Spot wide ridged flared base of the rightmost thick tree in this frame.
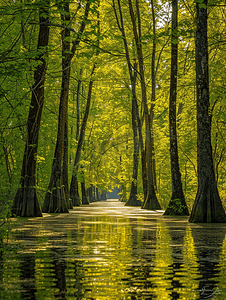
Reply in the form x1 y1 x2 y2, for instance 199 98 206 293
189 178 226 223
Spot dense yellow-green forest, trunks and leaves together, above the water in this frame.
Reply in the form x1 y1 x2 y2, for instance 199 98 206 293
0 0 226 222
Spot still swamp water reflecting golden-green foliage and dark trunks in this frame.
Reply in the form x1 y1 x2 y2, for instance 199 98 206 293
0 200 226 300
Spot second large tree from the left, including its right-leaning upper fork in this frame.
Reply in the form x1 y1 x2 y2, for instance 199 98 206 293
43 0 90 213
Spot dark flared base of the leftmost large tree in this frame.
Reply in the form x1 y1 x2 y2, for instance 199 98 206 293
11 187 42 217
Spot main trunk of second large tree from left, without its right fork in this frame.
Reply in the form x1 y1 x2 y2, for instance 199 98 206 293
43 2 71 213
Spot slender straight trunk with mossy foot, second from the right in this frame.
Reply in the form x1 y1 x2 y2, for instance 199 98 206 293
164 0 189 216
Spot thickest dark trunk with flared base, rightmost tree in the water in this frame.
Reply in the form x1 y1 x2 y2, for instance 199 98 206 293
189 0 226 223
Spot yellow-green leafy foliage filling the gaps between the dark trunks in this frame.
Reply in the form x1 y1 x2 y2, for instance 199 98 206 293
0 0 226 213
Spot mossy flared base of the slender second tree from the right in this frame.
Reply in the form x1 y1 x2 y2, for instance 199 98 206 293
163 199 189 216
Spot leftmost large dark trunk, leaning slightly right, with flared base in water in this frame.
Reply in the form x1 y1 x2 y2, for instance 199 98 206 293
12 1 49 217
